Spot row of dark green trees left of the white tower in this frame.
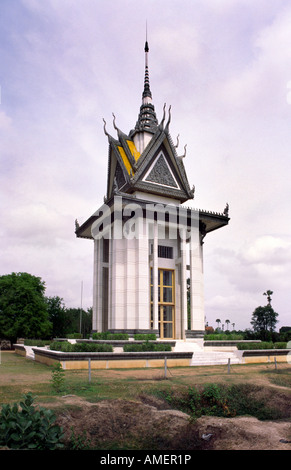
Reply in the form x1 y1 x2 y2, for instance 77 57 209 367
0 272 92 343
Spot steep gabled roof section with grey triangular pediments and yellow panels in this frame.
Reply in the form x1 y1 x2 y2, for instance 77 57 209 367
107 116 194 203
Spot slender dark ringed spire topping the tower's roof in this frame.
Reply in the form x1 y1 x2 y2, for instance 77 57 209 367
135 32 158 133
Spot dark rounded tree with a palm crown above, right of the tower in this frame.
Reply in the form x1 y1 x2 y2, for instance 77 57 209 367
251 291 278 340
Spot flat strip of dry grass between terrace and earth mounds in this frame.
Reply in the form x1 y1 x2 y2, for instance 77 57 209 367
0 351 291 404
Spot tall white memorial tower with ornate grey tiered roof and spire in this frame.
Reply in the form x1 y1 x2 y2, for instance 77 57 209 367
76 41 229 339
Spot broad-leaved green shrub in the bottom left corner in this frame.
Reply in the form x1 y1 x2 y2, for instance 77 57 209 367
0 393 63 450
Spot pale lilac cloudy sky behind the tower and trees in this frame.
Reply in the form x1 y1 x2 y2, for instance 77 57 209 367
0 0 291 330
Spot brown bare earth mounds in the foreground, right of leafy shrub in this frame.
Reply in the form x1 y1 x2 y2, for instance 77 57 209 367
54 396 291 450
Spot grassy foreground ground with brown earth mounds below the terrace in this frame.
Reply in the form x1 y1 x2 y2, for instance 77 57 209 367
0 351 291 450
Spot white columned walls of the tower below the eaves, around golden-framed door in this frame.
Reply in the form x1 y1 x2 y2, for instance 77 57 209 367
93 208 204 339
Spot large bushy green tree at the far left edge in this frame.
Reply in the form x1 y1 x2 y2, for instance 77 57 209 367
0 273 52 342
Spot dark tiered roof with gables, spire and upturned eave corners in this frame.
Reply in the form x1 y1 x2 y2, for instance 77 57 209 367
75 41 229 238
